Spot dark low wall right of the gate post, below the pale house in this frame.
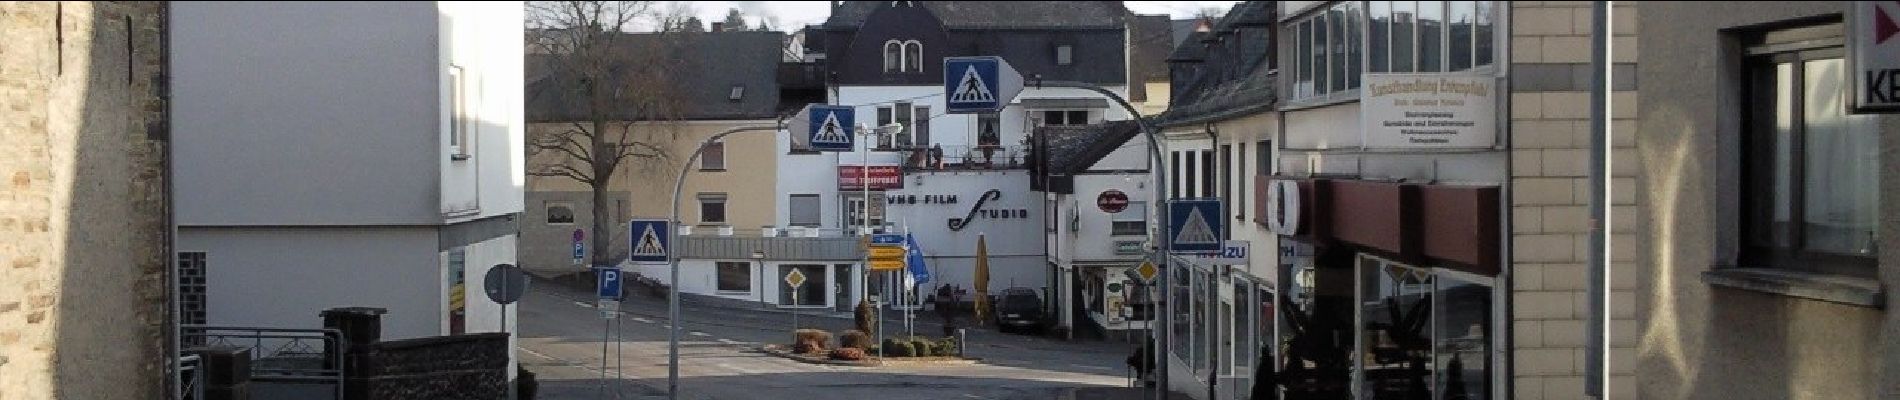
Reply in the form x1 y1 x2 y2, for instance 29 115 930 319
367 334 509 400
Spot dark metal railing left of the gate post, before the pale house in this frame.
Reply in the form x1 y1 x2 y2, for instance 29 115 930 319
181 324 346 398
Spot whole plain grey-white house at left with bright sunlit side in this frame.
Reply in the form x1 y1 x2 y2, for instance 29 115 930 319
169 2 526 346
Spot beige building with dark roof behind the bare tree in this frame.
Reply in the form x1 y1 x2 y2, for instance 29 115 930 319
521 30 804 282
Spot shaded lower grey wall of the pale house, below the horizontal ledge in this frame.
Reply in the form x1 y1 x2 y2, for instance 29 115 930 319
179 227 440 339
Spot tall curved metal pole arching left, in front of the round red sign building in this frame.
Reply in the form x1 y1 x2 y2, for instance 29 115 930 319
1036 82 1174 398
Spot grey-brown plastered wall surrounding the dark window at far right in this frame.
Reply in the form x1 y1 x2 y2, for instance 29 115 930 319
1634 2 1900 398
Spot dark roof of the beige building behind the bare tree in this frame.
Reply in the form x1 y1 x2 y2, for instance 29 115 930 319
524 32 785 121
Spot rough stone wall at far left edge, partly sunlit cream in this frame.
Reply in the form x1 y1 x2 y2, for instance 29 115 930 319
0 2 171 400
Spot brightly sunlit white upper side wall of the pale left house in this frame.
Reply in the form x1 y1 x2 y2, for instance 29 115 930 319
437 2 526 222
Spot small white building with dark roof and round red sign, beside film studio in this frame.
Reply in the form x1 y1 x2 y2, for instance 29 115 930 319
1030 121 1155 339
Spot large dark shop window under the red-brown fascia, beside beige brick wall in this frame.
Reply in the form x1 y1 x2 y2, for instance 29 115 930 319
1355 256 1495 398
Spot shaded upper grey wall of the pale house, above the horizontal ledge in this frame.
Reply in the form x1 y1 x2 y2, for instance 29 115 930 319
171 2 437 226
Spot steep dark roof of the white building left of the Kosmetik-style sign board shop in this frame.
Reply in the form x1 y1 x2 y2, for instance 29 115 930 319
1155 2 1277 127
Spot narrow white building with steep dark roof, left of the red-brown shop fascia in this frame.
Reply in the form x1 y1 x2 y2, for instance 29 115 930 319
1155 2 1281 398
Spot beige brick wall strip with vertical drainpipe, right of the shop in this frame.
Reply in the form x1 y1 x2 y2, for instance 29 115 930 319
1511 2 1640 400
